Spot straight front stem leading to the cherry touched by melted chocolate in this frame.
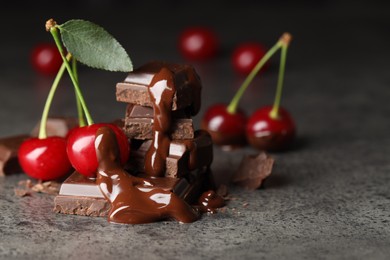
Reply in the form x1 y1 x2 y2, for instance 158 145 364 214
50 25 93 125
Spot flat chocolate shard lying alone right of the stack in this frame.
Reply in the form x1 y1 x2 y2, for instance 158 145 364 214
232 152 274 190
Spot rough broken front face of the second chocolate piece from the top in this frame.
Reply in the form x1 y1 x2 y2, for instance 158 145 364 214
123 118 194 140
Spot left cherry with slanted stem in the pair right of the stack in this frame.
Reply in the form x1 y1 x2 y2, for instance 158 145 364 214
201 34 281 148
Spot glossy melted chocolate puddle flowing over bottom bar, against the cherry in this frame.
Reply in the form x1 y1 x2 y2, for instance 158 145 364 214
95 127 199 224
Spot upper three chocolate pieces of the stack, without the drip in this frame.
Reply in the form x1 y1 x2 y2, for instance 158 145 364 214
116 62 213 178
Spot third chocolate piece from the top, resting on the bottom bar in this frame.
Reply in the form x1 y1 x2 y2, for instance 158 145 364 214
128 130 213 178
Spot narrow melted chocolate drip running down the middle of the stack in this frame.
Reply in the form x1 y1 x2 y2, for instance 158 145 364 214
145 67 176 177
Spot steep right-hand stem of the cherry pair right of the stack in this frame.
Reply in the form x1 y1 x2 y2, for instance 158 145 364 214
269 35 291 119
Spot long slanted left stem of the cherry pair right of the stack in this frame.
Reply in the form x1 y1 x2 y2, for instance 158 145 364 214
227 40 282 114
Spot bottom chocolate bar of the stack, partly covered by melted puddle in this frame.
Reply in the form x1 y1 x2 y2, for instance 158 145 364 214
54 171 207 217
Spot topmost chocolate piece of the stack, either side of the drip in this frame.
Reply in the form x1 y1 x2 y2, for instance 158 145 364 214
116 62 201 115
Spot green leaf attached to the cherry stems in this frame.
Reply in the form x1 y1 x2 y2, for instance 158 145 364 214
58 20 133 72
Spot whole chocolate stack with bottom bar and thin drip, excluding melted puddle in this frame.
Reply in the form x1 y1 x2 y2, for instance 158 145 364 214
55 62 213 216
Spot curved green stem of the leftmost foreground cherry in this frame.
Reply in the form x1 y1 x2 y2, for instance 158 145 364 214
38 54 72 139
